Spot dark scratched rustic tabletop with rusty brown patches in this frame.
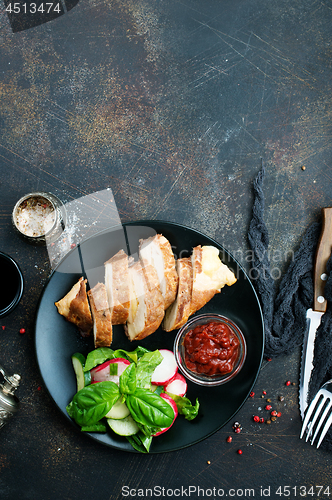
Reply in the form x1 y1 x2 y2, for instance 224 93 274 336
0 0 332 500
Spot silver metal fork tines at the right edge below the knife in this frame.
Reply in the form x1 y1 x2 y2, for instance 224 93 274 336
300 379 332 448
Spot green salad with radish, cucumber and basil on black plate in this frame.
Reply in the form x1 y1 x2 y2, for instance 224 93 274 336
66 347 199 453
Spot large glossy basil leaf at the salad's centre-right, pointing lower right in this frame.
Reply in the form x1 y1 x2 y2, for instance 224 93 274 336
126 389 174 427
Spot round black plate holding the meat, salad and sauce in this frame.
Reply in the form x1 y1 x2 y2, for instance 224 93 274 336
35 221 264 453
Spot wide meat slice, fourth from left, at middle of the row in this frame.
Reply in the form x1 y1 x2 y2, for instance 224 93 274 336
125 261 164 340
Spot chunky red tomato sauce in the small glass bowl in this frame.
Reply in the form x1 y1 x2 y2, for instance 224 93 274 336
183 322 240 375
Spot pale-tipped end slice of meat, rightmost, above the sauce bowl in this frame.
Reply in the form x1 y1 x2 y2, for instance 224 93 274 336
190 245 236 314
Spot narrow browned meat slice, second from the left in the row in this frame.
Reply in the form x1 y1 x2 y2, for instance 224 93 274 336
88 283 112 348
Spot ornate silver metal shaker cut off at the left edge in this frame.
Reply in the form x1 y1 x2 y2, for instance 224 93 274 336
0 366 21 429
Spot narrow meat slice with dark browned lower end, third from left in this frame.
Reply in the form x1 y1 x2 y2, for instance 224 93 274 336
105 250 130 325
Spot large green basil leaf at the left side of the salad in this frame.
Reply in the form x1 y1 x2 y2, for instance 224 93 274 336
67 381 120 427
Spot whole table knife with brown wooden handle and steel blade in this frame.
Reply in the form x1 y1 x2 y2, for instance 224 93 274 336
299 207 332 419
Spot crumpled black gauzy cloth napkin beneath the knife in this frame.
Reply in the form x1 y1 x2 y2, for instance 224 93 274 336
248 166 332 451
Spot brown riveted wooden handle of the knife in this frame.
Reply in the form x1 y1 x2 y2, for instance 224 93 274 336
313 207 332 313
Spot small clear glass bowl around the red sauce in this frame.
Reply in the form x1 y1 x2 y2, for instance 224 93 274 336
173 313 247 387
